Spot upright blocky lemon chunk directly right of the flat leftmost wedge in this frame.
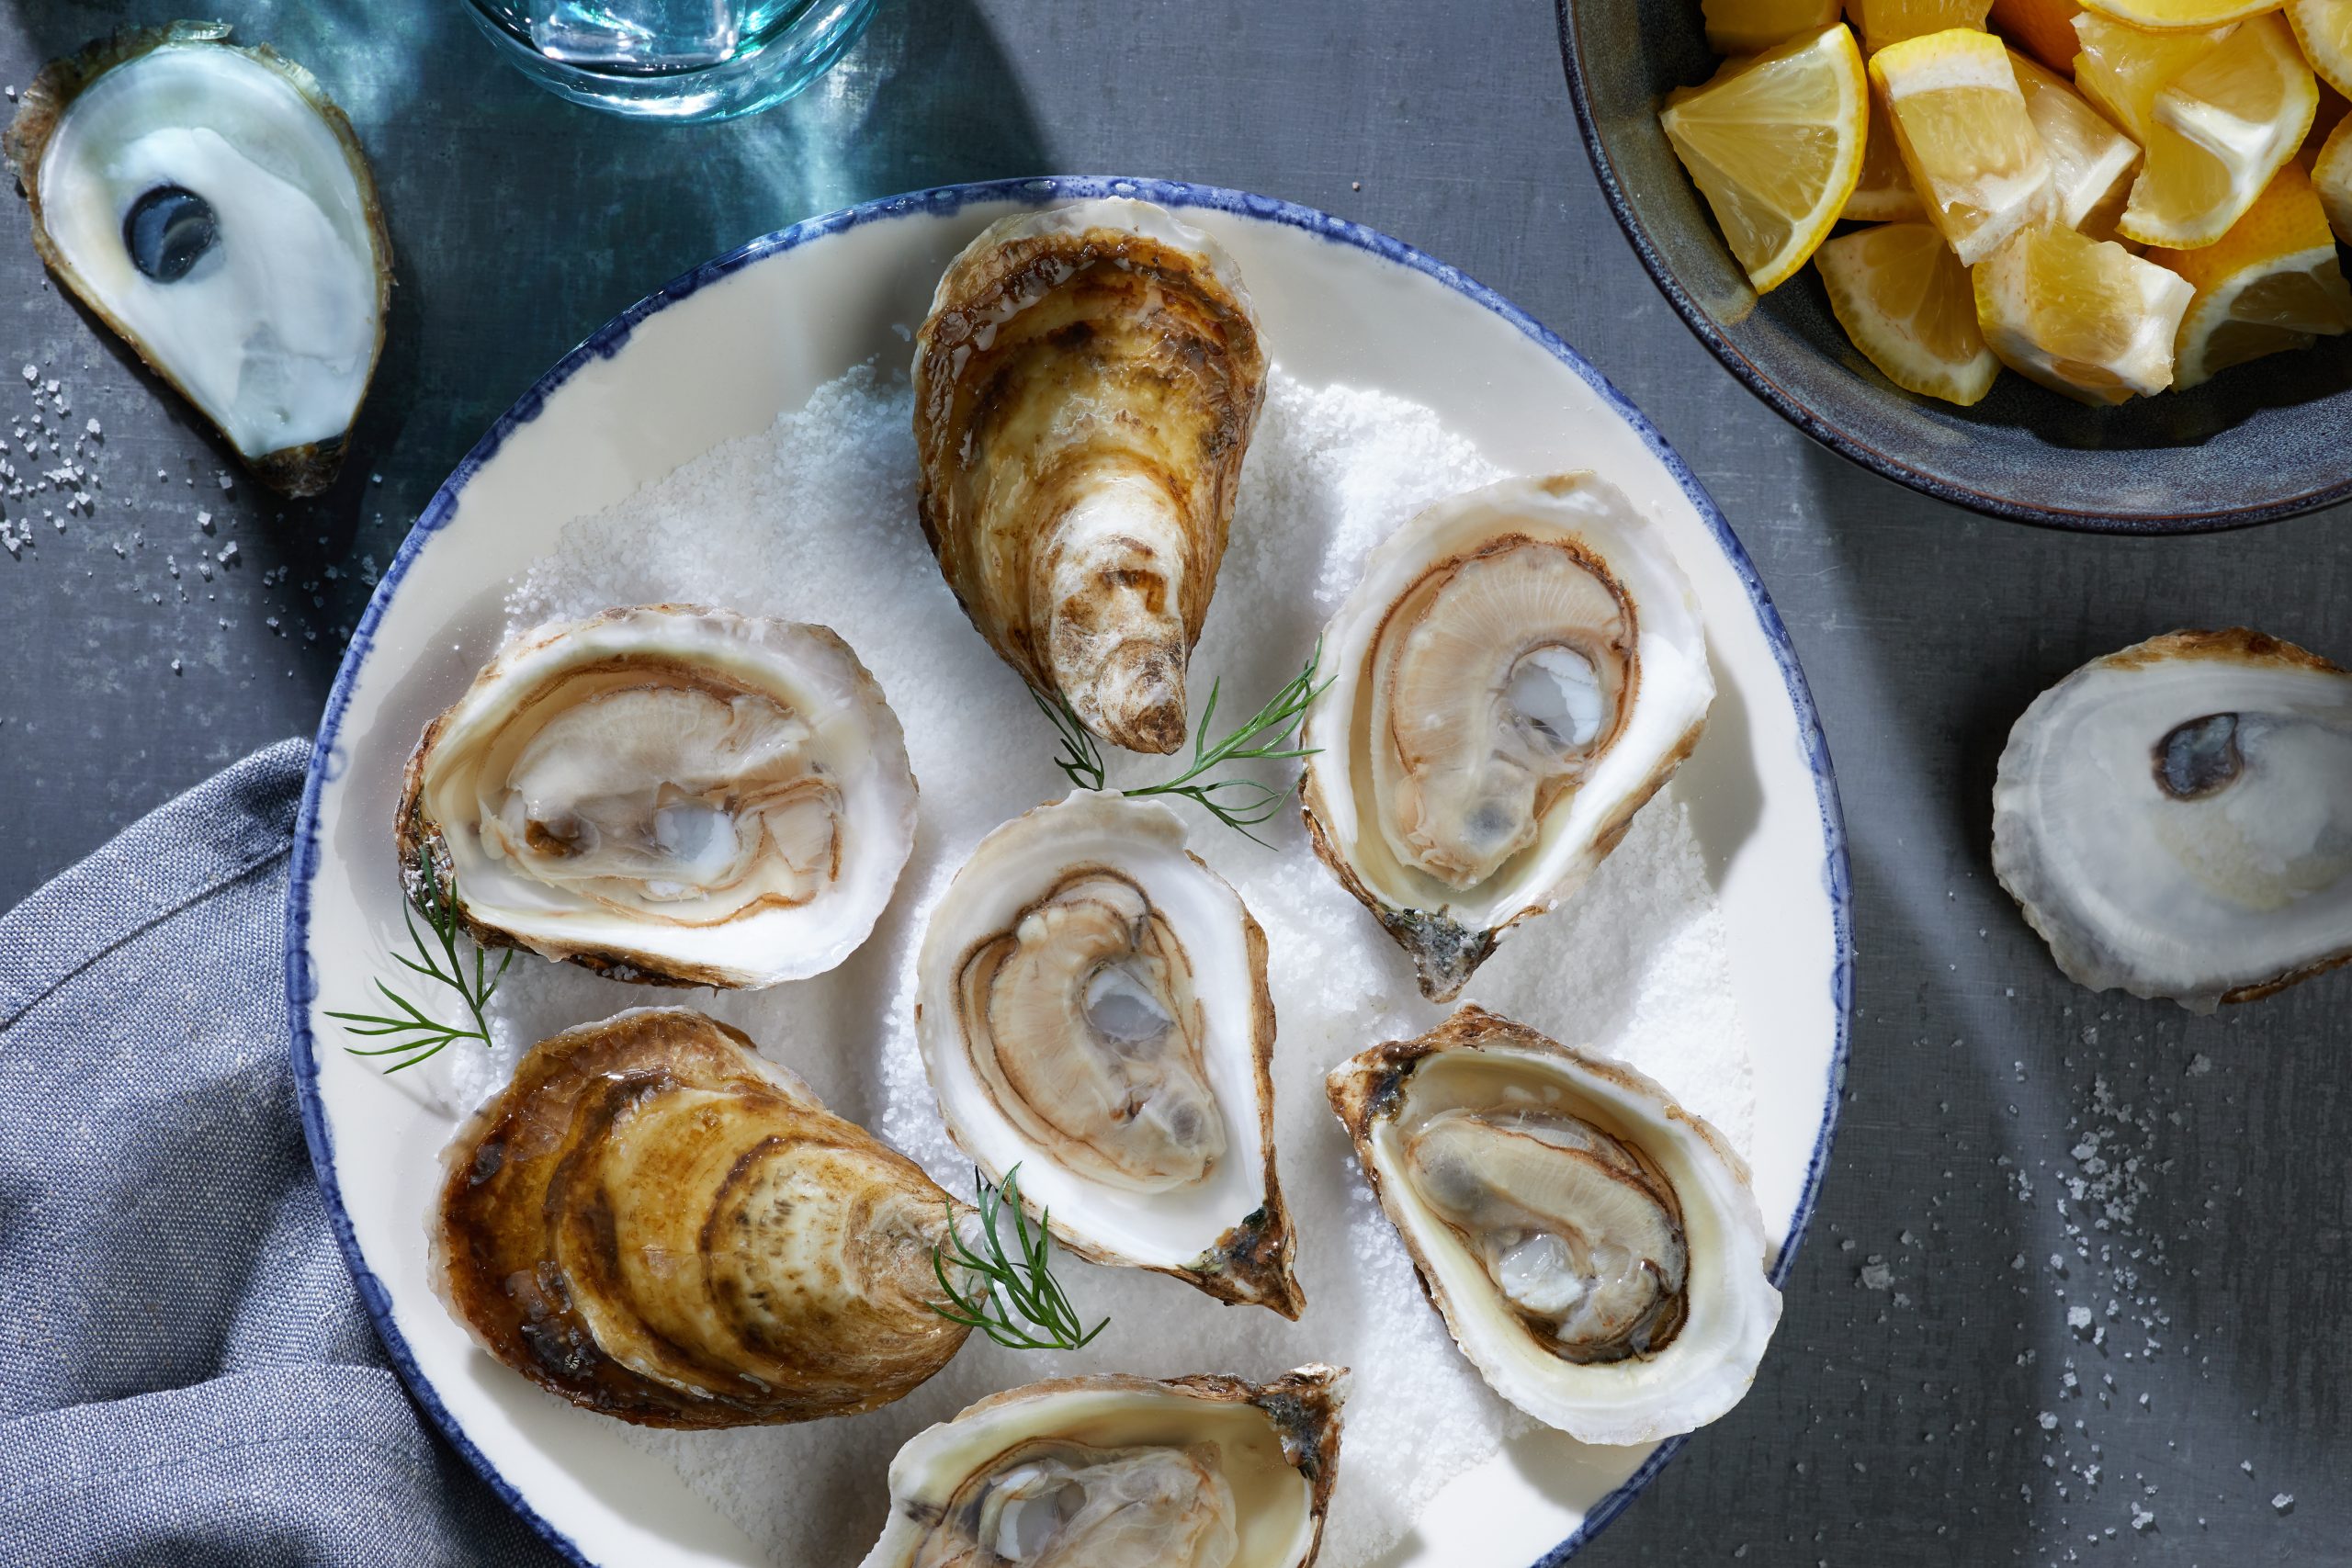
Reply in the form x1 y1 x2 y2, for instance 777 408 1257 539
1870 28 2058 265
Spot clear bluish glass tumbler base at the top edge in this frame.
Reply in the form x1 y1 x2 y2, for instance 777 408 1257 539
466 0 877 120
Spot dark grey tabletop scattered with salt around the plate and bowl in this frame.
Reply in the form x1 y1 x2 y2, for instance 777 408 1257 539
0 0 2352 1565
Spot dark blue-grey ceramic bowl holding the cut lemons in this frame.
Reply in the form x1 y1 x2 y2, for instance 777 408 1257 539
1555 0 2352 534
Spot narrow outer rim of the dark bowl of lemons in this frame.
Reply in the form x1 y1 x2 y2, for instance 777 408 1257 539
1553 0 2352 536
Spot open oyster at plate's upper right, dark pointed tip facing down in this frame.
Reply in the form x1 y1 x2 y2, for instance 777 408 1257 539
1301 472 1714 1001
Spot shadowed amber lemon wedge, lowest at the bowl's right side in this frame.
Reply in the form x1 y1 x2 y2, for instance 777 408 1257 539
2154 163 2352 388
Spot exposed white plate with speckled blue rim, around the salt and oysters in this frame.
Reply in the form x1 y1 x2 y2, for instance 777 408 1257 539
287 179 1851 1568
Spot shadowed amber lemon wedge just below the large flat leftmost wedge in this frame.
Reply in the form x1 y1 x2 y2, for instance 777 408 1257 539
1814 223 2002 407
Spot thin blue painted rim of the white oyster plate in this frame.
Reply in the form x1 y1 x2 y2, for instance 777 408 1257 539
285 174 1853 1568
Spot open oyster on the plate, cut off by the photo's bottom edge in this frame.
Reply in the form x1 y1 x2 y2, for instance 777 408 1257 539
864 1366 1348 1568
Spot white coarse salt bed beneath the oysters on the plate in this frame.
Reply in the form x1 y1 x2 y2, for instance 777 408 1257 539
430 367 1752 1568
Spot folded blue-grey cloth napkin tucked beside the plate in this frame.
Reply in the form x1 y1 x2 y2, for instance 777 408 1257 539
0 740 560 1568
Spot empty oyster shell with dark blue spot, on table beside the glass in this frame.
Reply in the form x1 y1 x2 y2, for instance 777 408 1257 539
0 21 393 496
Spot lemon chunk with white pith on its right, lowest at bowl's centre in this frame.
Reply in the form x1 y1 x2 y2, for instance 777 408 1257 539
1973 223 2197 404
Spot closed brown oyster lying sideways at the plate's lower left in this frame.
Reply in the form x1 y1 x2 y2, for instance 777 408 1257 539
430 1009 967 1427
